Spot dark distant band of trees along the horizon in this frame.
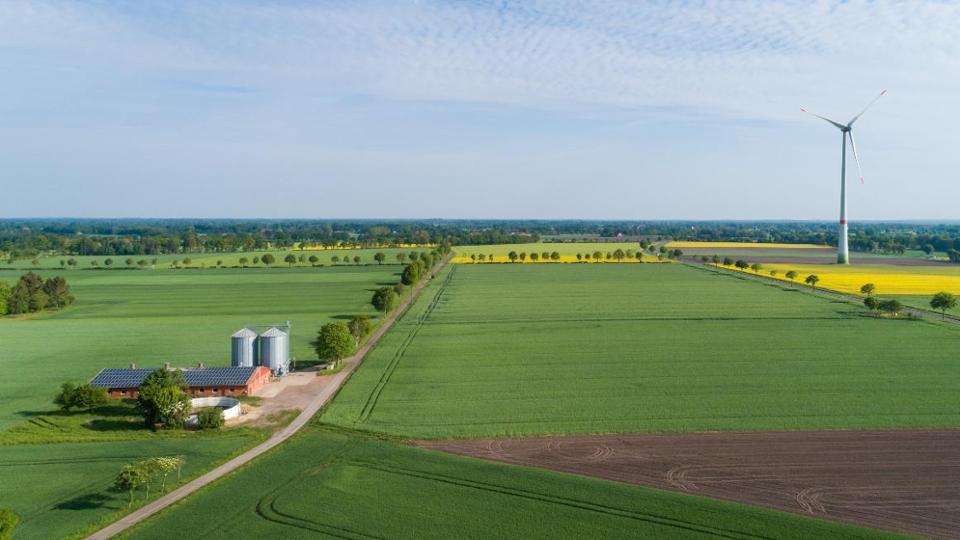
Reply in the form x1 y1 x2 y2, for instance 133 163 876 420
0 219 960 262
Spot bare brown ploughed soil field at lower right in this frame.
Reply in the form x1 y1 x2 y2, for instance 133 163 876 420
417 430 960 538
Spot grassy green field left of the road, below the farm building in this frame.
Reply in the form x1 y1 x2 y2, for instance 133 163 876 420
0 435 255 540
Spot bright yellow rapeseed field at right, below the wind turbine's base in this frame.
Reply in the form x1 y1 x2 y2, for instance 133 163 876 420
746 263 960 295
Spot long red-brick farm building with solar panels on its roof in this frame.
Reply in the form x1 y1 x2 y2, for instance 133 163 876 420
90 366 270 398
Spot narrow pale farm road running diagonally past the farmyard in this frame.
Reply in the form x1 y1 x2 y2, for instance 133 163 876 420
86 257 449 540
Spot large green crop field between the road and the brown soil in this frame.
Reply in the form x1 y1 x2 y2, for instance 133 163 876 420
323 265 960 438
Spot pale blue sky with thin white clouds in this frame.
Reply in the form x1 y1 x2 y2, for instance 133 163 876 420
0 0 960 221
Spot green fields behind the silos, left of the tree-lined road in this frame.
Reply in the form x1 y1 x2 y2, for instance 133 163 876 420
0 265 399 430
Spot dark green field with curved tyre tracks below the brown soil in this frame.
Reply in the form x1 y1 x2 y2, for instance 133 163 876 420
124 427 886 539
